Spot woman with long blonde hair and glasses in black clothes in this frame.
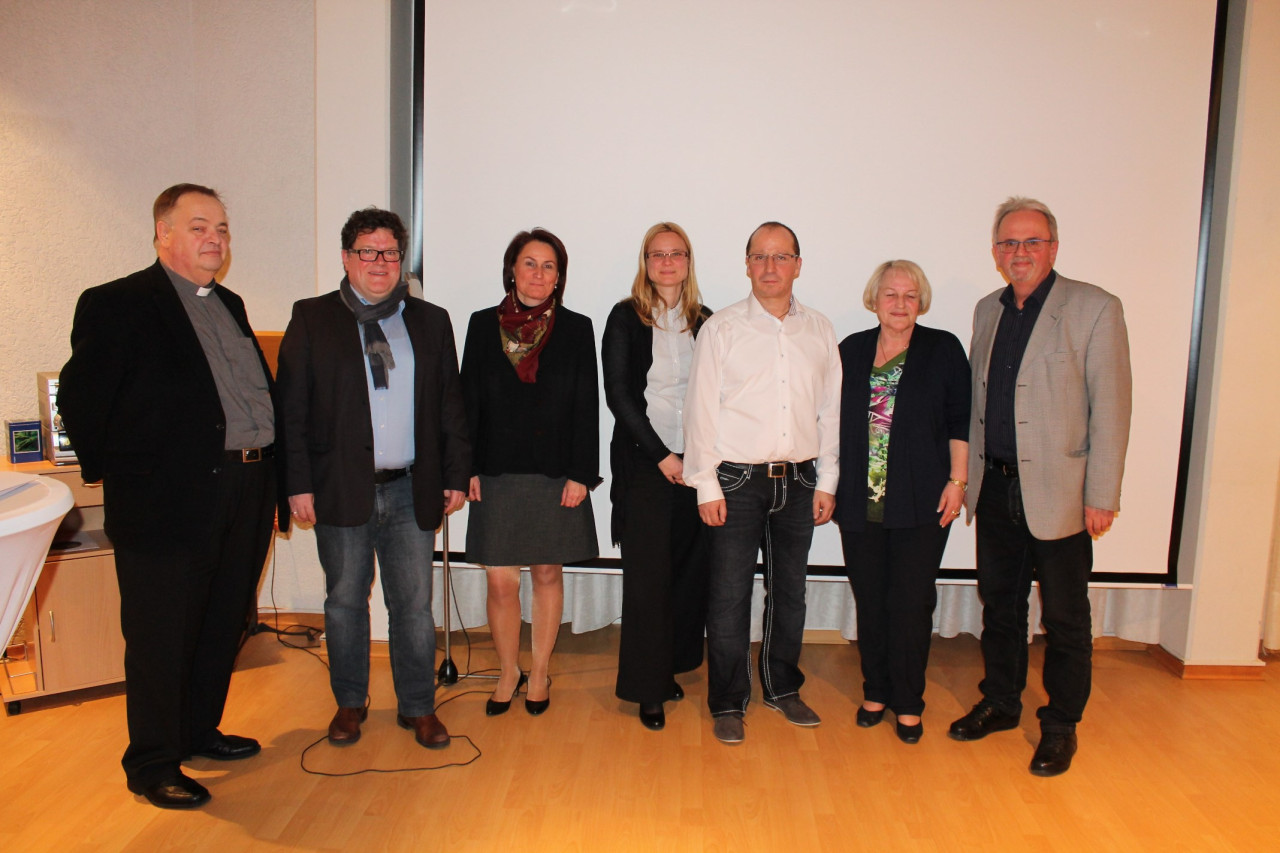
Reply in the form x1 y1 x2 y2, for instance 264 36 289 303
602 222 710 729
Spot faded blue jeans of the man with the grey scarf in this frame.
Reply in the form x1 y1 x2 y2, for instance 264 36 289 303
315 474 435 717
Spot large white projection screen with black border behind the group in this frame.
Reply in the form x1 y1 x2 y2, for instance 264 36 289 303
421 0 1215 583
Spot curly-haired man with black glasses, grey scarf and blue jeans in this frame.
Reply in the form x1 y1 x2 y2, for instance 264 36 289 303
279 207 471 749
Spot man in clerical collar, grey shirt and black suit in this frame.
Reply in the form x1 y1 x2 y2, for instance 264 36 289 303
58 183 278 808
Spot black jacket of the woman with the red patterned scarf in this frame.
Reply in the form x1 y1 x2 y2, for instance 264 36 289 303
462 305 600 488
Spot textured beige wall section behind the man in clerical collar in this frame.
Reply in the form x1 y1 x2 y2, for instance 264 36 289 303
0 0 316 418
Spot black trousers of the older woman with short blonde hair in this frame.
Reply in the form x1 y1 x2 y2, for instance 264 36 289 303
840 521 954 715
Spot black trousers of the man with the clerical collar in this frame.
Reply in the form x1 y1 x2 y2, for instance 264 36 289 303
115 459 275 785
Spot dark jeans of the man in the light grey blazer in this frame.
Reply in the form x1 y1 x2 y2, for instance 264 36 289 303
977 470 1093 731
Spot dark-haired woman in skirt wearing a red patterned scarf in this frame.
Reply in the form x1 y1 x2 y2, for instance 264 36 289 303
462 228 600 716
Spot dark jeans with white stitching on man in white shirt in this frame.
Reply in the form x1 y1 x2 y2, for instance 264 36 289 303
707 460 817 716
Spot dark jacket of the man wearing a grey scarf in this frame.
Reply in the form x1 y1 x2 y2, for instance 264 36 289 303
278 291 471 530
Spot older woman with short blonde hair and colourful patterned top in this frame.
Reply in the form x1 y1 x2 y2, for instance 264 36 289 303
836 260 970 743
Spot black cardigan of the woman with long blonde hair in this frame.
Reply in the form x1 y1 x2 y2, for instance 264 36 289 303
600 297 712 544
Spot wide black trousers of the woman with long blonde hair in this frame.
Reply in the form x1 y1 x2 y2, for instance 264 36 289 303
616 440 707 702
